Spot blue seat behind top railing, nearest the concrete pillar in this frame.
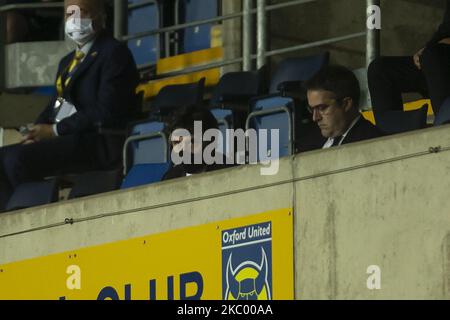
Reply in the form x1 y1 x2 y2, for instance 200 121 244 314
176 0 218 53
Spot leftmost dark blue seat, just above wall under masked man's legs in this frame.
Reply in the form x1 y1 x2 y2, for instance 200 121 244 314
6 179 58 211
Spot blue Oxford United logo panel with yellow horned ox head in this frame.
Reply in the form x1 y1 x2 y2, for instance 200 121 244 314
222 222 272 300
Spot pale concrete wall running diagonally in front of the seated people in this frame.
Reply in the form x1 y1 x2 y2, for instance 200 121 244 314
0 127 450 299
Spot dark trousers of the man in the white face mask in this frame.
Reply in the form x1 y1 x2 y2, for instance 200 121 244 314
0 135 121 212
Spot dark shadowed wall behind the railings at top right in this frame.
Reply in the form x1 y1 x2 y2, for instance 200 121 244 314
270 0 445 69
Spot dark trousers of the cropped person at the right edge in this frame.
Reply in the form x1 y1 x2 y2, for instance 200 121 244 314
368 44 450 117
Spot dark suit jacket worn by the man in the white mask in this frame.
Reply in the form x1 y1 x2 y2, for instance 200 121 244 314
36 33 139 136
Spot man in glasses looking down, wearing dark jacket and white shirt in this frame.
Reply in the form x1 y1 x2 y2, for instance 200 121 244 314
297 66 381 152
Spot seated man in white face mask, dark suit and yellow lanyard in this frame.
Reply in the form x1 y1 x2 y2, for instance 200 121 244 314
0 0 139 211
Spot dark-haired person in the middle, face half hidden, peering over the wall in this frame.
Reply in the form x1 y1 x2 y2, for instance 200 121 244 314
163 106 230 180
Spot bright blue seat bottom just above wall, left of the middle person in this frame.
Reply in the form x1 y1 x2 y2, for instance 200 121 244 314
121 163 170 189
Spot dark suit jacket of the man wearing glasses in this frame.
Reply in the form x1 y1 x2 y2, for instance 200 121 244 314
296 116 383 152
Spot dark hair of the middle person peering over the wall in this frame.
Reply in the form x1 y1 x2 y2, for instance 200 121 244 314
167 106 219 134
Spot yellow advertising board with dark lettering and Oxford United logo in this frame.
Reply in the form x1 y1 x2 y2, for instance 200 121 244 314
0 209 294 300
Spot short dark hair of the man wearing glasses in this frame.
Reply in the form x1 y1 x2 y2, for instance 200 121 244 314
303 65 361 109
